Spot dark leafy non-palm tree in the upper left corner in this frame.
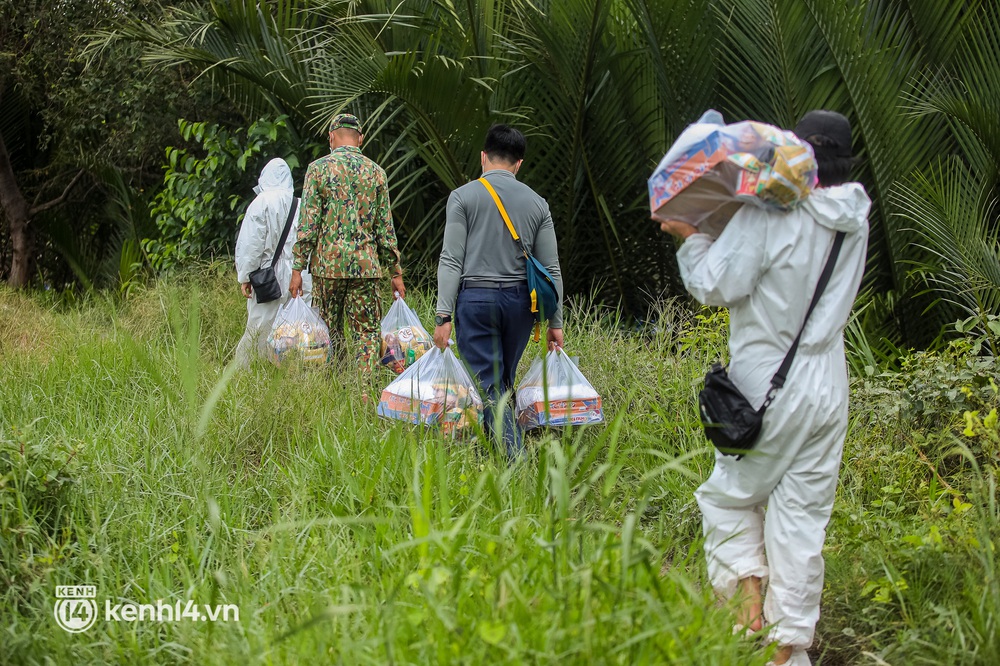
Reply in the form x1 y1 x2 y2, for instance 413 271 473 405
0 0 237 289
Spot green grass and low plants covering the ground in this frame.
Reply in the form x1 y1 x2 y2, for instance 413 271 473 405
0 264 1000 666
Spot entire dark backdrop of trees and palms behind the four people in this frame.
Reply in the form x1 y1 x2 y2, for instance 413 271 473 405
0 0 1000 348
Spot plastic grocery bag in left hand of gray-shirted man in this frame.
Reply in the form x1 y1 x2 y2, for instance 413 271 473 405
378 347 483 433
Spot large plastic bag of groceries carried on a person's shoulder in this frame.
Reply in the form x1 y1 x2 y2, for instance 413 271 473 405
648 111 818 235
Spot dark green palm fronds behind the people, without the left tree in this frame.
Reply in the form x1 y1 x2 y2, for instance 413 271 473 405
95 0 1000 342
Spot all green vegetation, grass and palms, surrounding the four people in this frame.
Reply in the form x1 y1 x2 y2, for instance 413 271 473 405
0 0 1000 666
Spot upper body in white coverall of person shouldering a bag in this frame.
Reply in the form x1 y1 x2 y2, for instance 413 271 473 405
681 183 871 406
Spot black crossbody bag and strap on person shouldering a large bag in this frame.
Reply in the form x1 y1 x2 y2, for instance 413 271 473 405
698 231 846 460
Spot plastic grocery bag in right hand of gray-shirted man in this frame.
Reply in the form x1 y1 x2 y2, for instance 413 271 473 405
517 349 604 430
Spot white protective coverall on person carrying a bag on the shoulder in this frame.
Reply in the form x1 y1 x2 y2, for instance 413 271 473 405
677 183 871 666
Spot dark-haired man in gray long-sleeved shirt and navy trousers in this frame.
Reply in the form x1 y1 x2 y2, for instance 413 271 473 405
434 125 563 457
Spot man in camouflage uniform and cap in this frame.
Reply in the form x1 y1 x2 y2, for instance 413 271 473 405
289 113 406 371
